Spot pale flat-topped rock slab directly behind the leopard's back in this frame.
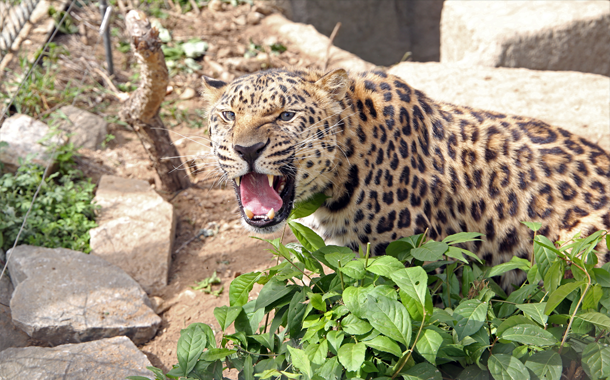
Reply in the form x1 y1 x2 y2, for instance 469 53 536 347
388 62 610 151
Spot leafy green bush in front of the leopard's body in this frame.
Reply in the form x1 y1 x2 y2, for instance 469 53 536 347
137 196 610 380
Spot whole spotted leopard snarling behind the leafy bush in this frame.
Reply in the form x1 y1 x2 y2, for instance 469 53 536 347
203 68 610 289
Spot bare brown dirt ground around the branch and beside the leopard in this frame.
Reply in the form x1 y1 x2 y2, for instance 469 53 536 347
0 0 319 371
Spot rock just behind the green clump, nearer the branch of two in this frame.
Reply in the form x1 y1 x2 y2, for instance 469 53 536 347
53 106 108 150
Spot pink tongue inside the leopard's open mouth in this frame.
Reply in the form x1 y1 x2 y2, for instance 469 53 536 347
239 173 283 216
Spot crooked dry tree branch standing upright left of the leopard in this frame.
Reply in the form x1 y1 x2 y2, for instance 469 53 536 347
120 10 190 192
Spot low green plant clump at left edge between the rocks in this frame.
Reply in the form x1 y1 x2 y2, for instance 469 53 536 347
0 144 97 253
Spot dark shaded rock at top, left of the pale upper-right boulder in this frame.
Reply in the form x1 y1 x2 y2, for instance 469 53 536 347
283 0 443 66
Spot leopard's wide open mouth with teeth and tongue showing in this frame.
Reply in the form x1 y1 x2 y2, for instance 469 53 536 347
233 172 295 228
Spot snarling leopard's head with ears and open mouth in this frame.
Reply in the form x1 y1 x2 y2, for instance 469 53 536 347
204 69 349 233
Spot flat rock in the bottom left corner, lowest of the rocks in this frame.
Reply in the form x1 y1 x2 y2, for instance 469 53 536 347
0 337 154 380
